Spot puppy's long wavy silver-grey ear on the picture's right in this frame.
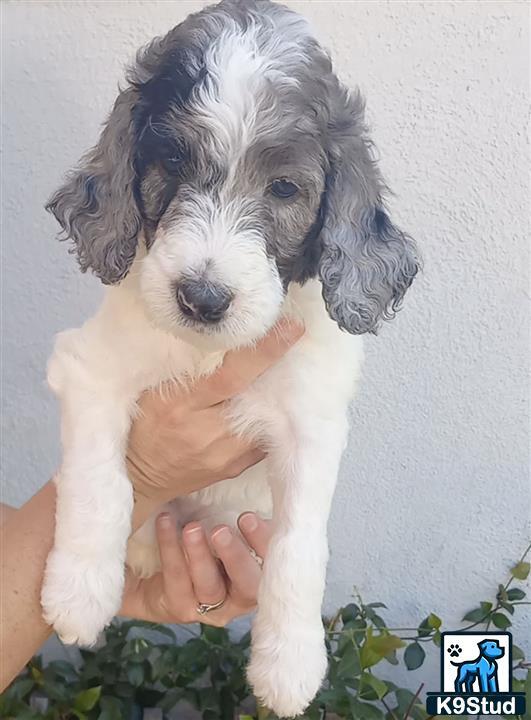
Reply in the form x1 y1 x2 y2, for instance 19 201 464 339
319 77 419 334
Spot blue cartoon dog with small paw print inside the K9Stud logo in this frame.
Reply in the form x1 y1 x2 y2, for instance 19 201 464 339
448 639 505 693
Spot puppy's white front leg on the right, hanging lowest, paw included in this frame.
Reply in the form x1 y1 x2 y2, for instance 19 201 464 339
249 417 347 717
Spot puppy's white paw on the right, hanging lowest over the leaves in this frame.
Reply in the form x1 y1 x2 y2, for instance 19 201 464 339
247 616 327 717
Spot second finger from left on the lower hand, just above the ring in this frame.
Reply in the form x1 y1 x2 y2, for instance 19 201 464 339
183 522 227 605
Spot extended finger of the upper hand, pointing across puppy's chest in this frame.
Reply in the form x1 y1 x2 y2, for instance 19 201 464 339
189 319 304 408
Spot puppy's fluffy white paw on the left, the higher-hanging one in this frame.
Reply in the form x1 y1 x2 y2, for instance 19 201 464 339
41 548 124 646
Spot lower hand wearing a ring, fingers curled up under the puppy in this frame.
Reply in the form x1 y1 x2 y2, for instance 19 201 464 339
120 513 271 627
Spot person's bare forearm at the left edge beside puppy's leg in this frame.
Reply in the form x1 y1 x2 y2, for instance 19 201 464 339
0 482 55 690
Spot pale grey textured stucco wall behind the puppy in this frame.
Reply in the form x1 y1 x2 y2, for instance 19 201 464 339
2 0 531 688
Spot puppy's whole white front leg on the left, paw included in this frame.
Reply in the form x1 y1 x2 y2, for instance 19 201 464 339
41 346 133 645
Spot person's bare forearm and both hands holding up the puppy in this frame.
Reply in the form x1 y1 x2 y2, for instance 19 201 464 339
0 323 303 689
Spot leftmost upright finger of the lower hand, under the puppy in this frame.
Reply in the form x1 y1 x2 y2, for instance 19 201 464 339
157 513 194 601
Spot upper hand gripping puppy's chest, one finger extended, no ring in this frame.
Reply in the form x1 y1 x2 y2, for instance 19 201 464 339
127 320 304 518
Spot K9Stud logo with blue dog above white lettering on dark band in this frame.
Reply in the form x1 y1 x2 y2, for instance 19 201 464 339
426 632 525 715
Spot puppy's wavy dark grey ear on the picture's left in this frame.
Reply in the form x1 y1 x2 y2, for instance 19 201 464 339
46 88 141 285
